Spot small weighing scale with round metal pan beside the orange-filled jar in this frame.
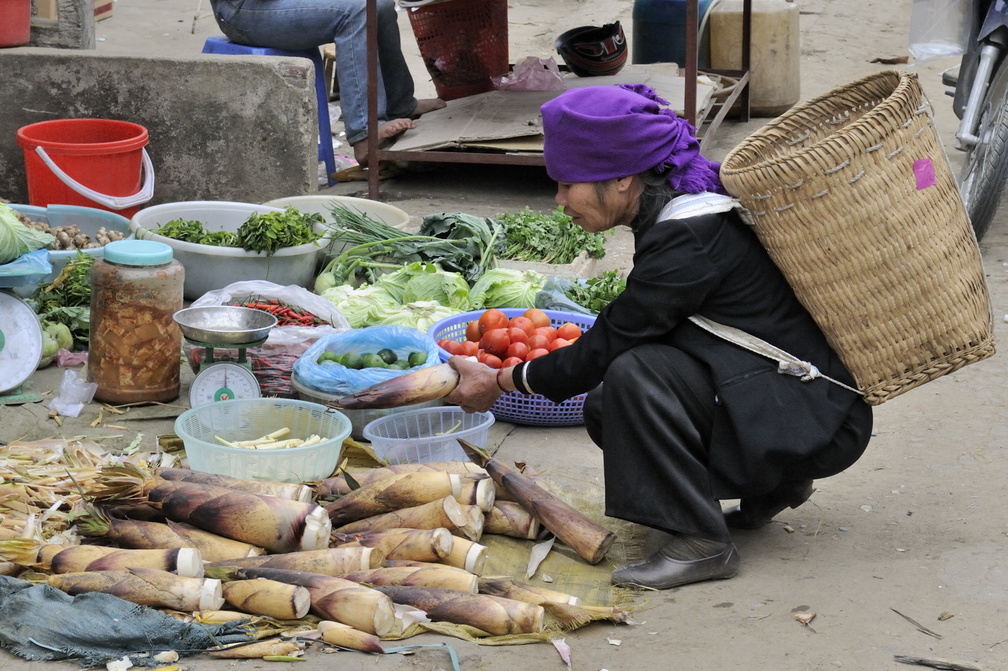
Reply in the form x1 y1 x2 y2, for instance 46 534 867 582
173 305 277 408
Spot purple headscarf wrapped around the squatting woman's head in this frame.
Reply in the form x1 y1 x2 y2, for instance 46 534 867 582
540 84 725 193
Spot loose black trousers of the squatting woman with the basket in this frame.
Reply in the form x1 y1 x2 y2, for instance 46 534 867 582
585 345 871 541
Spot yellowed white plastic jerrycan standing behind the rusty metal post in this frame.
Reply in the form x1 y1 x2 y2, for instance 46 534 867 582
711 0 801 117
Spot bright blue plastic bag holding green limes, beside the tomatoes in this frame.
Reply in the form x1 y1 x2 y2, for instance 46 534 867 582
294 325 440 396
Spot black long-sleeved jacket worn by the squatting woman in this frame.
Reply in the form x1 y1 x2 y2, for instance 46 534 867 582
526 206 871 498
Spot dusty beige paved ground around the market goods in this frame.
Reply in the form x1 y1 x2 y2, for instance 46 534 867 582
0 0 1008 671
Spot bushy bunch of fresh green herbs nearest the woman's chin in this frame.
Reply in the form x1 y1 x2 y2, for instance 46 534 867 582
498 207 606 264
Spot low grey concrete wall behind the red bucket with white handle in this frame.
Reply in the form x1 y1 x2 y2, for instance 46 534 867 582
0 47 319 209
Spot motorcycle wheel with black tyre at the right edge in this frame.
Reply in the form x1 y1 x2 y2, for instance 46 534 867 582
960 58 1008 240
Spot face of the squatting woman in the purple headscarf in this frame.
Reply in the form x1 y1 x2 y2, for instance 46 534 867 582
555 177 637 233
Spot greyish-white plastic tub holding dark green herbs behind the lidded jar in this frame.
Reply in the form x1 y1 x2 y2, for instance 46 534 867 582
129 200 327 300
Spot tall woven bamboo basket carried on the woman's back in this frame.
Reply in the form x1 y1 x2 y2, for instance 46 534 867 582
721 71 994 405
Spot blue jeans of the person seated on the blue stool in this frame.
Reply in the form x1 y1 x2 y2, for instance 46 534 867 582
211 0 416 145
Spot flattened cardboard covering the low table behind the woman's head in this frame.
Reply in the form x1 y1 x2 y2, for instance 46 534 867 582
388 63 715 153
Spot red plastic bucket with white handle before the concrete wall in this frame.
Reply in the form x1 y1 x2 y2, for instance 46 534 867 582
17 119 154 219
